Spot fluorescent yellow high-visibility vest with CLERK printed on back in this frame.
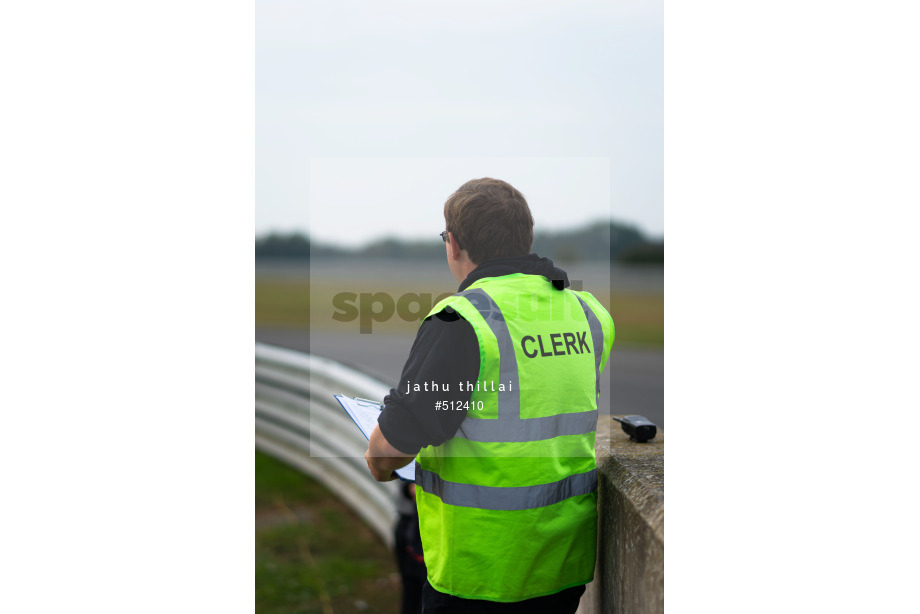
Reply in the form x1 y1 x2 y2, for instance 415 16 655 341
415 273 614 602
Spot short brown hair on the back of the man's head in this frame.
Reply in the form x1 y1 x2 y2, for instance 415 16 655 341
444 177 533 264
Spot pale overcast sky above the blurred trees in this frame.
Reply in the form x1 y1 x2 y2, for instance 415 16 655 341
256 0 664 245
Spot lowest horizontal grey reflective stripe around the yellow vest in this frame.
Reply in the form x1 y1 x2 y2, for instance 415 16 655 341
415 462 597 510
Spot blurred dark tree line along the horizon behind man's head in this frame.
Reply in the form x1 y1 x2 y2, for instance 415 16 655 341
255 221 664 264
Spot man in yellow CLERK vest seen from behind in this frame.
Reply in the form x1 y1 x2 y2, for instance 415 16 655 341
365 178 614 614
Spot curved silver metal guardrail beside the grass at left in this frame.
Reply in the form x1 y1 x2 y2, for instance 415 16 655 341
255 343 397 548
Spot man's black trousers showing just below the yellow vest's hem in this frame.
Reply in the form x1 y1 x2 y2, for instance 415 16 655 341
422 580 585 614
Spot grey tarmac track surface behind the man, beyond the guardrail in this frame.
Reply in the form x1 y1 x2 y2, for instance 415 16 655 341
255 327 664 429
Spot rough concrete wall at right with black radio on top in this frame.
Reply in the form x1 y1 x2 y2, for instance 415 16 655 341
578 418 664 614
